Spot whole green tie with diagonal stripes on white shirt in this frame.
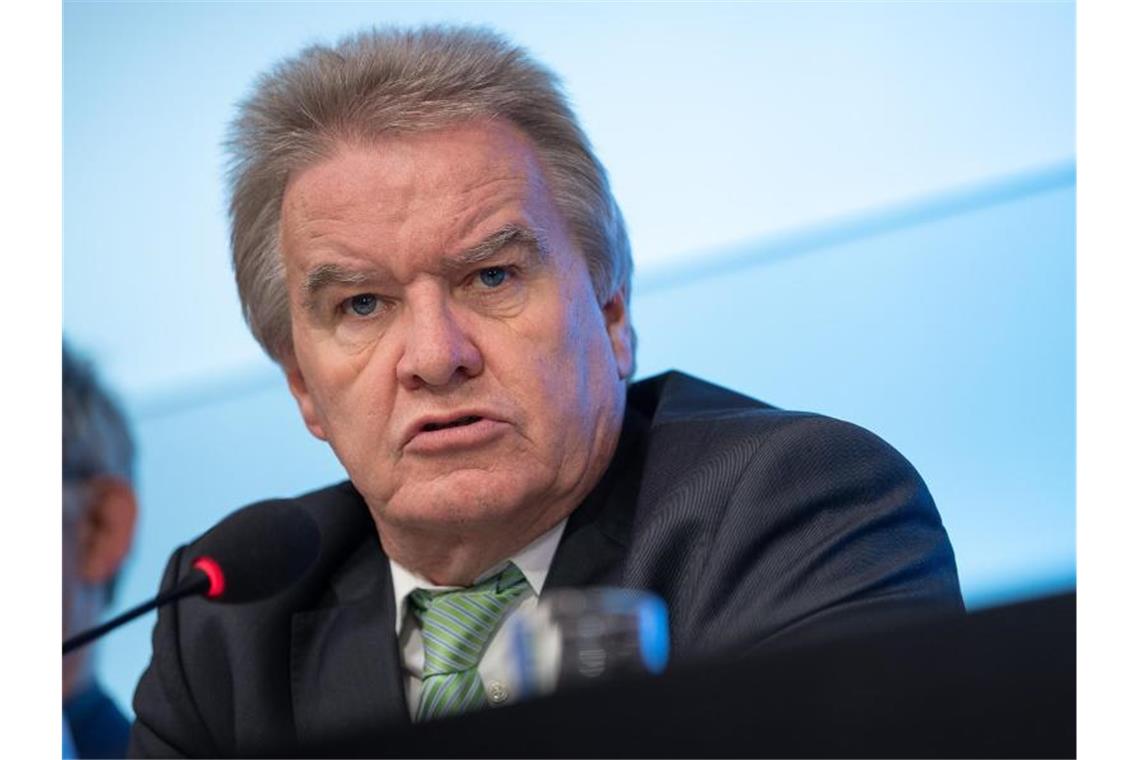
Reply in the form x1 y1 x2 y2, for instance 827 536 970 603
409 564 528 720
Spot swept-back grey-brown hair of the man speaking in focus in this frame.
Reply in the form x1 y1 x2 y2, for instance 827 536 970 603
227 26 633 362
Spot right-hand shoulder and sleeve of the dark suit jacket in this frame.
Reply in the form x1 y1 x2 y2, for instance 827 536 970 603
629 373 961 654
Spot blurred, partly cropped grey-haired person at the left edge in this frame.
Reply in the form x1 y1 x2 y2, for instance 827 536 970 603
63 344 137 758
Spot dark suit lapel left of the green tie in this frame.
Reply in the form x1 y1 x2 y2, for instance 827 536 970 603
291 541 409 755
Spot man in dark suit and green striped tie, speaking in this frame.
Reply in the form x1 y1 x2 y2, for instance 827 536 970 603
133 28 961 755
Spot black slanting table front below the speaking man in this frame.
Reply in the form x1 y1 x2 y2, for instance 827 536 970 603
323 593 1076 758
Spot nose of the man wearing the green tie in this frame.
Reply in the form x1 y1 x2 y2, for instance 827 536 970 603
396 292 483 390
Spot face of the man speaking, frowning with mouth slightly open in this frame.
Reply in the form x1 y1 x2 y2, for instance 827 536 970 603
280 121 633 540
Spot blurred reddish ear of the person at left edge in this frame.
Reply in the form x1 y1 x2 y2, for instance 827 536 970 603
79 475 138 586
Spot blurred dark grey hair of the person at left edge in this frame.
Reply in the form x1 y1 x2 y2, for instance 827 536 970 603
63 343 135 483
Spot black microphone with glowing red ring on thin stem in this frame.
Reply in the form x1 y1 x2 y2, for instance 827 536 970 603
64 501 320 654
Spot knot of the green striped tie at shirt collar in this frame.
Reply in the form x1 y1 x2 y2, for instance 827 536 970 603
409 563 527 678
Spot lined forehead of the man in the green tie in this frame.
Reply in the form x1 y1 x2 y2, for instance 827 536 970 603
282 121 555 259
